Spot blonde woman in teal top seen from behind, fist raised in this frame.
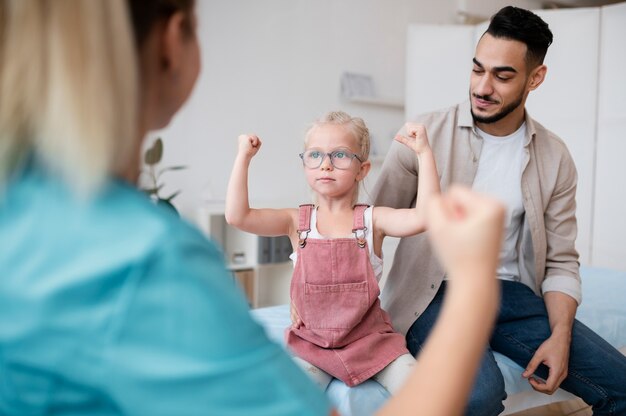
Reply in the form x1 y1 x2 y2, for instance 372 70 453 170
0 0 502 415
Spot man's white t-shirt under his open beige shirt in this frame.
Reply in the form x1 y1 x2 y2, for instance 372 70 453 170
472 123 526 281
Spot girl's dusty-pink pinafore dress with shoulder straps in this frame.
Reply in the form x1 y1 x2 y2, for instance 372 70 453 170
285 205 409 387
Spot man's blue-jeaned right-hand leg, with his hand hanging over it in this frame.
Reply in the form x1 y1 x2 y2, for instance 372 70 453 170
491 281 626 415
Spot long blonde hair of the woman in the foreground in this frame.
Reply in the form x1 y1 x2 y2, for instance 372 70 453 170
0 0 138 195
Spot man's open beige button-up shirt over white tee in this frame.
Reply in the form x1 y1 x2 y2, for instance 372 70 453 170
373 101 582 334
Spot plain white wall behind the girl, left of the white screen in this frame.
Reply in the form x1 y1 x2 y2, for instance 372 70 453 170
148 0 455 219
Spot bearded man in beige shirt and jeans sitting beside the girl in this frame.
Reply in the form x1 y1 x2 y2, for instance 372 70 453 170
374 6 626 415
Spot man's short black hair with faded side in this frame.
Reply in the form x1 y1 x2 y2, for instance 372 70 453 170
485 6 552 69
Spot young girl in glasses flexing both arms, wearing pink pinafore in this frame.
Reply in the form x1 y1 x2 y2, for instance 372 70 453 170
226 112 439 394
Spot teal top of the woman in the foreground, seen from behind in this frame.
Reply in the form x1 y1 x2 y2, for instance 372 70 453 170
0 163 330 416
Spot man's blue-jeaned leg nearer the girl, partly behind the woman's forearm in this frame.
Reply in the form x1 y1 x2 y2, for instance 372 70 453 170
406 282 506 416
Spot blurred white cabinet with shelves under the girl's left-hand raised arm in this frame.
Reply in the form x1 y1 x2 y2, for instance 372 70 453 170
195 205 293 308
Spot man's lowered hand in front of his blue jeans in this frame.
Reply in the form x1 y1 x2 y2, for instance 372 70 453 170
522 333 570 394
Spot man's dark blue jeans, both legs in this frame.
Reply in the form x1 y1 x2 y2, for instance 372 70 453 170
406 281 626 416
